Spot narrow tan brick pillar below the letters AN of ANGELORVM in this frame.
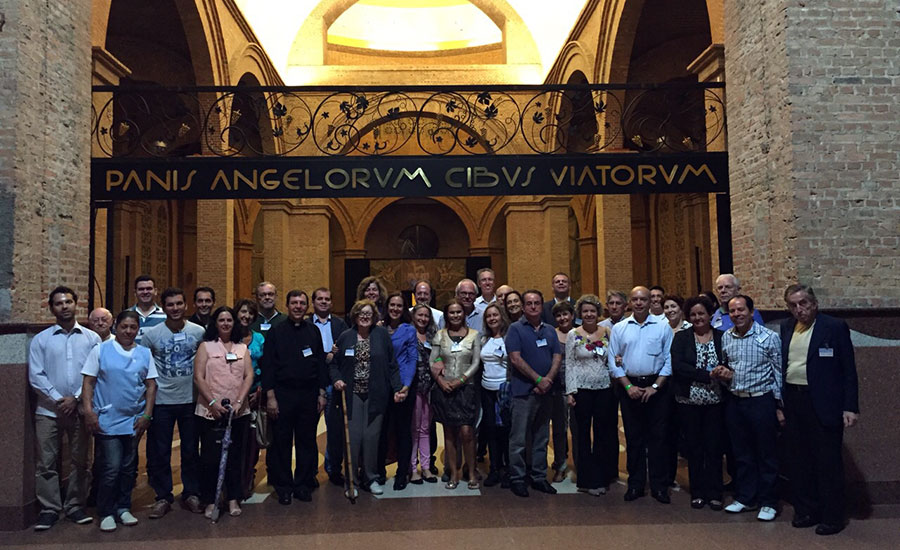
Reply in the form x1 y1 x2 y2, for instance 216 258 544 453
196 199 234 304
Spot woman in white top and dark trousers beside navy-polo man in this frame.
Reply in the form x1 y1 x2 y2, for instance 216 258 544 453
480 303 509 487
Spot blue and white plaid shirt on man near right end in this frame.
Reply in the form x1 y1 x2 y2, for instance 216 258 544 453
722 321 781 401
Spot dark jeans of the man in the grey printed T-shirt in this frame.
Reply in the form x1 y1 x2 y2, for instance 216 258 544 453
147 403 200 502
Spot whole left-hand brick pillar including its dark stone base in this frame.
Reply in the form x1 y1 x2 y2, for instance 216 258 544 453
0 0 91 530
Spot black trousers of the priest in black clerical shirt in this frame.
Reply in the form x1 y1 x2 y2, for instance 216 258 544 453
268 387 319 494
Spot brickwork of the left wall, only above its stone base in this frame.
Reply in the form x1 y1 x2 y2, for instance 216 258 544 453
0 0 91 322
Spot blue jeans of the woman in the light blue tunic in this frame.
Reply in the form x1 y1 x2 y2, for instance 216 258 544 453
94 434 137 517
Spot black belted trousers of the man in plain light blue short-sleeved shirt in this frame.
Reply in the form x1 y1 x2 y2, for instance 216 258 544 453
621 382 670 492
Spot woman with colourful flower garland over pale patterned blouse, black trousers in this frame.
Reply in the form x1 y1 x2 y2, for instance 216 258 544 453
566 294 619 496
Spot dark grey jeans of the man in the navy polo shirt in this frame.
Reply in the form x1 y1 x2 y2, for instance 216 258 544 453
509 393 553 483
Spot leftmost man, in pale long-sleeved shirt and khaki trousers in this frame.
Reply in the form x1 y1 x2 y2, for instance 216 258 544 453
28 286 100 531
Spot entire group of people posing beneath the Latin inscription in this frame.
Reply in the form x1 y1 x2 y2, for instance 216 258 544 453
29 269 859 534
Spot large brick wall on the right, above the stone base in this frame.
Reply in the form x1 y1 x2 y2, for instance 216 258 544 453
725 0 900 308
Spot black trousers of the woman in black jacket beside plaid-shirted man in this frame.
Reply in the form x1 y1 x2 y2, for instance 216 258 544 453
678 403 725 501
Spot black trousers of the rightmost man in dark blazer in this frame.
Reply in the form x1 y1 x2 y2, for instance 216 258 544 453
784 384 844 525
